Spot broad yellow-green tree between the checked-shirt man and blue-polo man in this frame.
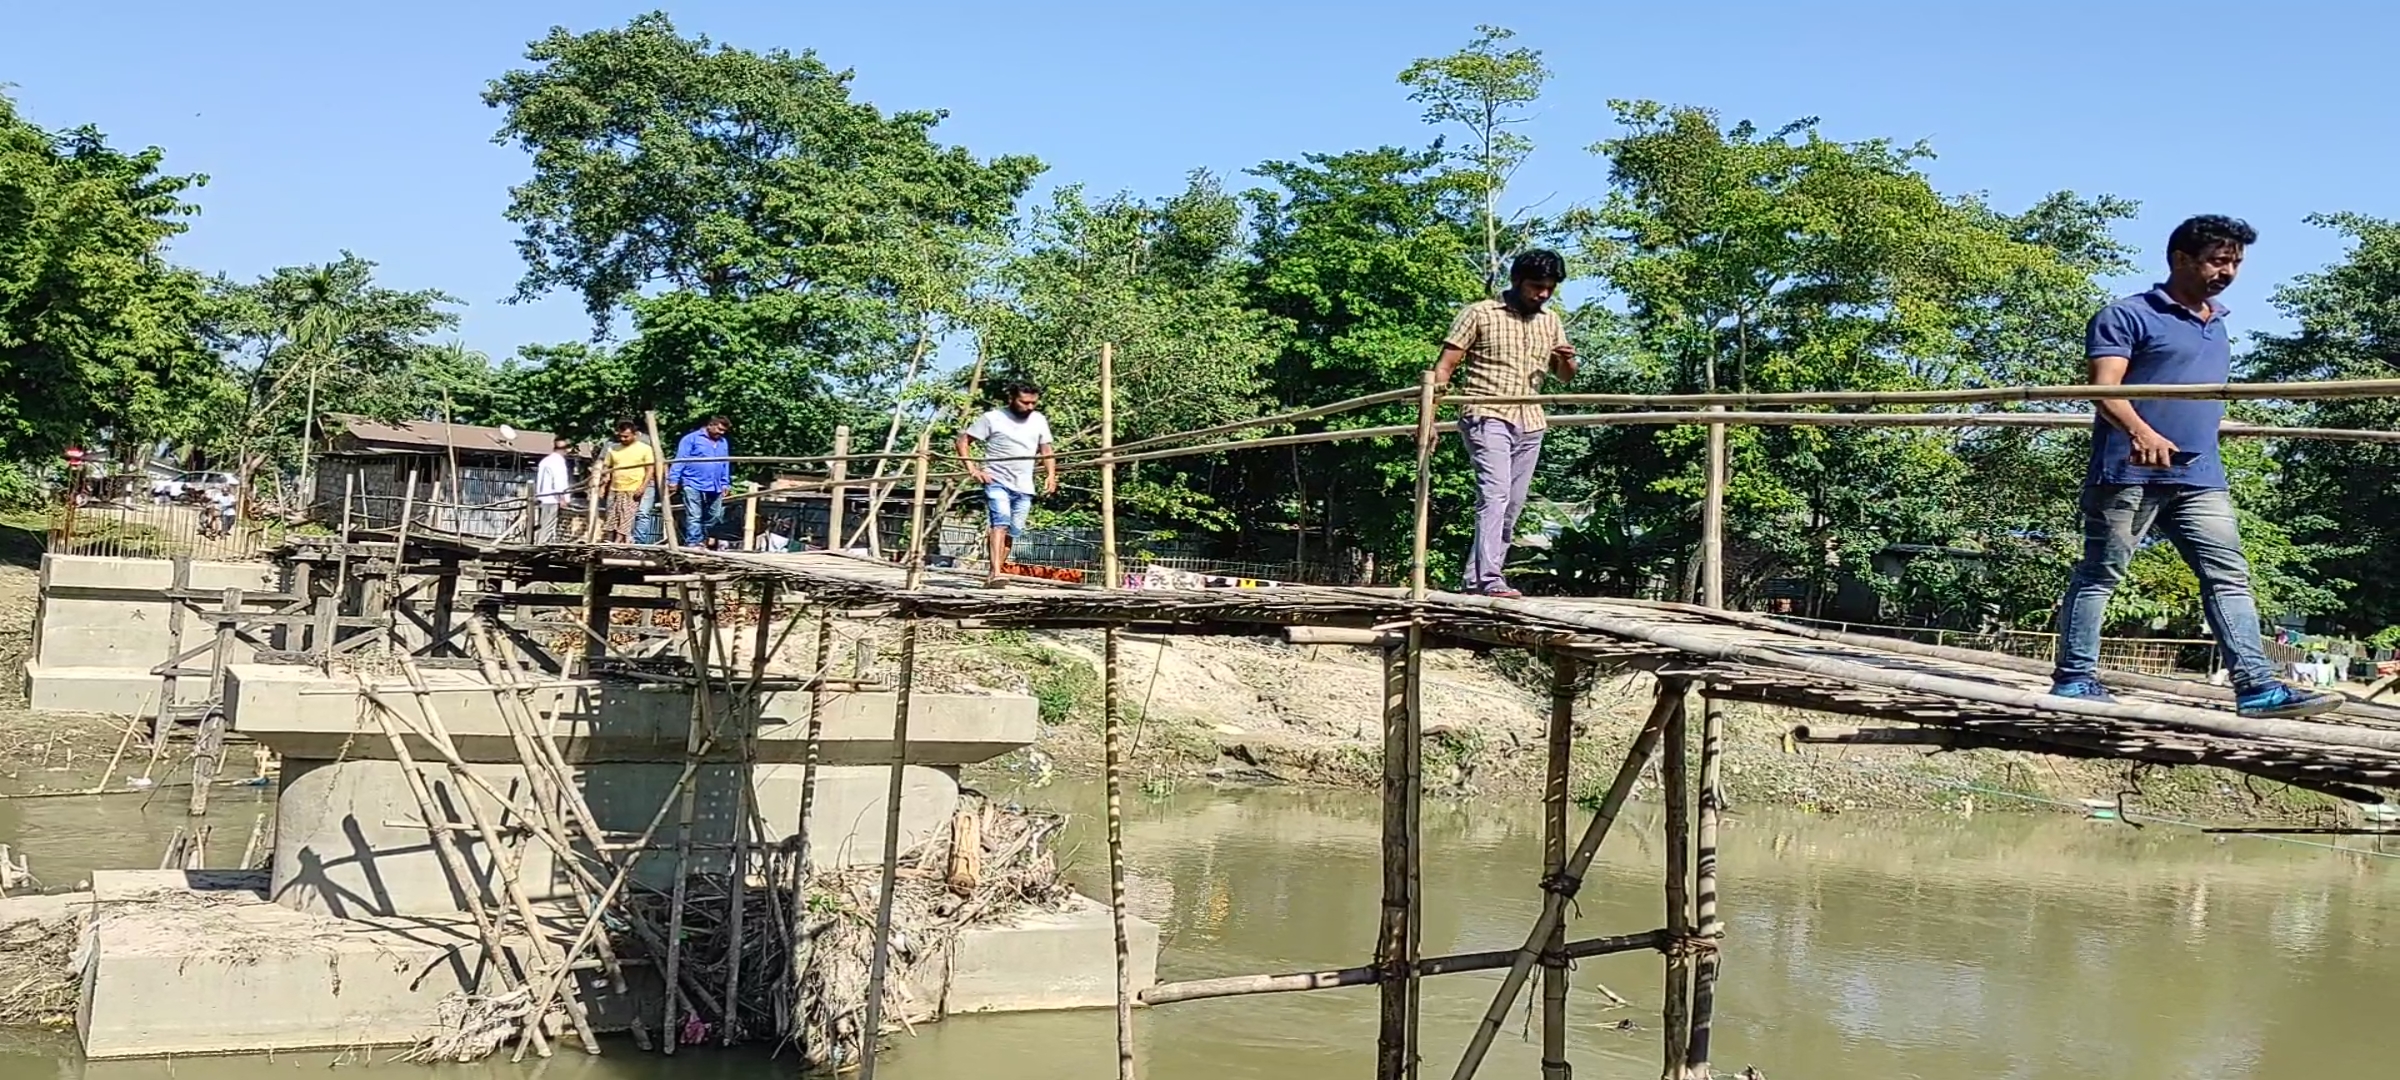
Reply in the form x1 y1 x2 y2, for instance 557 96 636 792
1550 103 2131 622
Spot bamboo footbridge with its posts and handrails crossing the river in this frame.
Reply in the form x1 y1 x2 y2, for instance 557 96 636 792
333 357 2400 1080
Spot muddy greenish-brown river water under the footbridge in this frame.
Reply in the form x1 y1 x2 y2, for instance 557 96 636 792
0 785 2400 1080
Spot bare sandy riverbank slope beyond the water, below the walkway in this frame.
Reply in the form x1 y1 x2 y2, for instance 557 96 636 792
917 631 2354 823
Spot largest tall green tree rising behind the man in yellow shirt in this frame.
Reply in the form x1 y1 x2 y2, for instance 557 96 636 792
485 12 1042 454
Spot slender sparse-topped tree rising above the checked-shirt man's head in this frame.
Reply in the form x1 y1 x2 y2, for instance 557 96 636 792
1399 26 1550 293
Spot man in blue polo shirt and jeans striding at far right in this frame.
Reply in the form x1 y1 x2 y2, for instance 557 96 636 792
2050 214 2342 718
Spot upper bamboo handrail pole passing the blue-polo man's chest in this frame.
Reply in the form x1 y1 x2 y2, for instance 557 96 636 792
1447 379 2400 408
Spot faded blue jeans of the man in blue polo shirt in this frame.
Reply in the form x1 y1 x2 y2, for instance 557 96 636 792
2052 485 2275 691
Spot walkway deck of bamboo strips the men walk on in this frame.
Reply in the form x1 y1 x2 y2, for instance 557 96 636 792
518 545 2400 802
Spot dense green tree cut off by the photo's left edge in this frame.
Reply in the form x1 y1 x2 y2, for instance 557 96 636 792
0 96 223 461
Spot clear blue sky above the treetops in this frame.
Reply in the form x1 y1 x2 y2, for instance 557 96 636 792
0 0 2400 358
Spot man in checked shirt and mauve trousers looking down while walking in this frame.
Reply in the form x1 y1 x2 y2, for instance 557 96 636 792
1433 250 1574 598
